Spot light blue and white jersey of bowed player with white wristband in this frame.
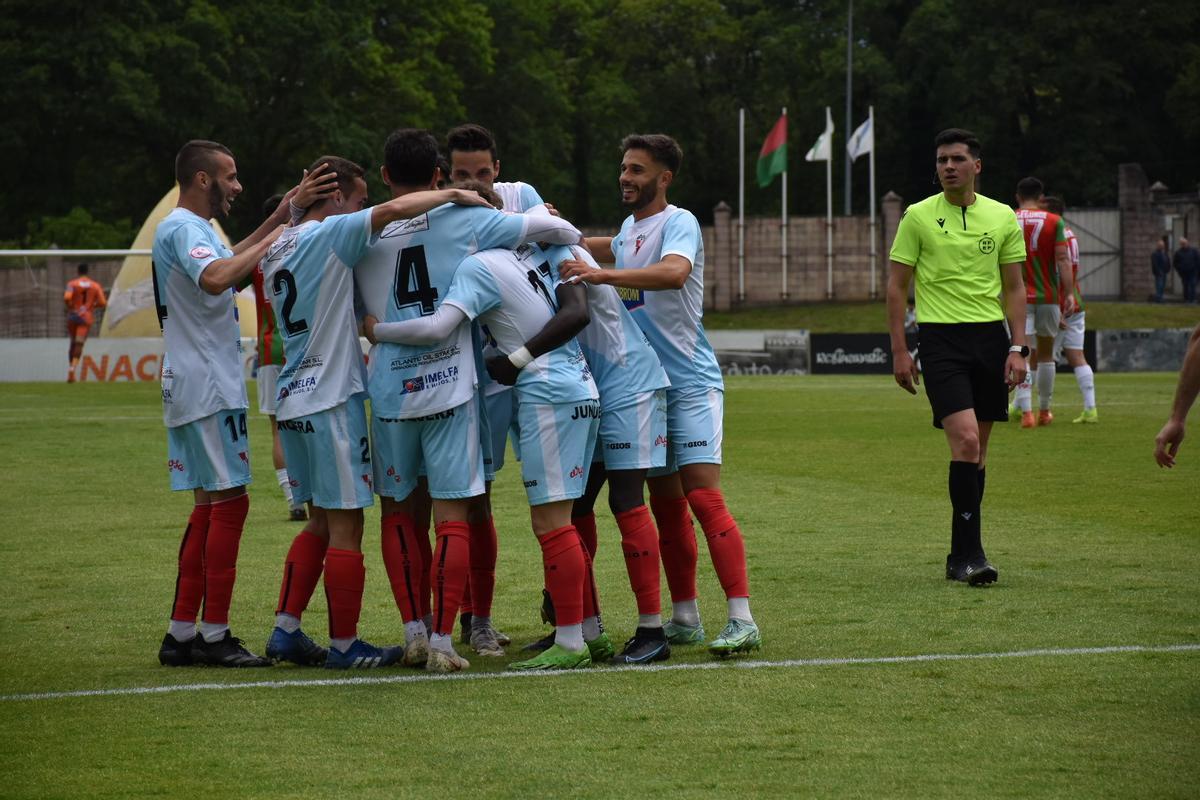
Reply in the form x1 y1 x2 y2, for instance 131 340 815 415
446 245 599 403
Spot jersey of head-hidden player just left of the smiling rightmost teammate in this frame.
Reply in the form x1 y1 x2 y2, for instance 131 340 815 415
539 247 671 409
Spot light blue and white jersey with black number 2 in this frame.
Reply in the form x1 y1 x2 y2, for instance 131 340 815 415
263 209 372 420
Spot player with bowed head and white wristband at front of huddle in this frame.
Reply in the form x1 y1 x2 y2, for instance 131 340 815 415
368 235 613 669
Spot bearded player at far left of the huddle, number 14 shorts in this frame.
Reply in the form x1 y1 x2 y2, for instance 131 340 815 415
151 139 336 667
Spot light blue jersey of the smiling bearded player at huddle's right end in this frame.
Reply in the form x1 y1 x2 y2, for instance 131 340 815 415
612 205 724 389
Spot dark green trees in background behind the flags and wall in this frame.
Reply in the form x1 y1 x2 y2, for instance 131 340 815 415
0 0 1200 247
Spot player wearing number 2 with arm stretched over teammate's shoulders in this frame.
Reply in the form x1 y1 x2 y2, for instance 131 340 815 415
263 156 486 669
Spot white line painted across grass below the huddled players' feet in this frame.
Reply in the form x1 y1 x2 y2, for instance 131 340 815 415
0 644 1200 702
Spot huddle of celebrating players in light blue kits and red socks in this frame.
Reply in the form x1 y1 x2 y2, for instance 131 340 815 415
147 125 762 673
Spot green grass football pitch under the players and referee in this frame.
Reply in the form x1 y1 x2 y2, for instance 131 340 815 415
0 374 1200 798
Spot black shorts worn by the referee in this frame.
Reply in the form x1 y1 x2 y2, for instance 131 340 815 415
917 321 1009 428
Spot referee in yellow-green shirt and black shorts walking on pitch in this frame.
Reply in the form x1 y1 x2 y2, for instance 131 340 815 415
888 128 1030 587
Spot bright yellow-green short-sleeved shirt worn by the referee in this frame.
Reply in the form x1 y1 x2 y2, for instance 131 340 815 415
890 192 1025 323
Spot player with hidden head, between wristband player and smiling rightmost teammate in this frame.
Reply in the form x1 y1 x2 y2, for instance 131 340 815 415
528 247 671 664
